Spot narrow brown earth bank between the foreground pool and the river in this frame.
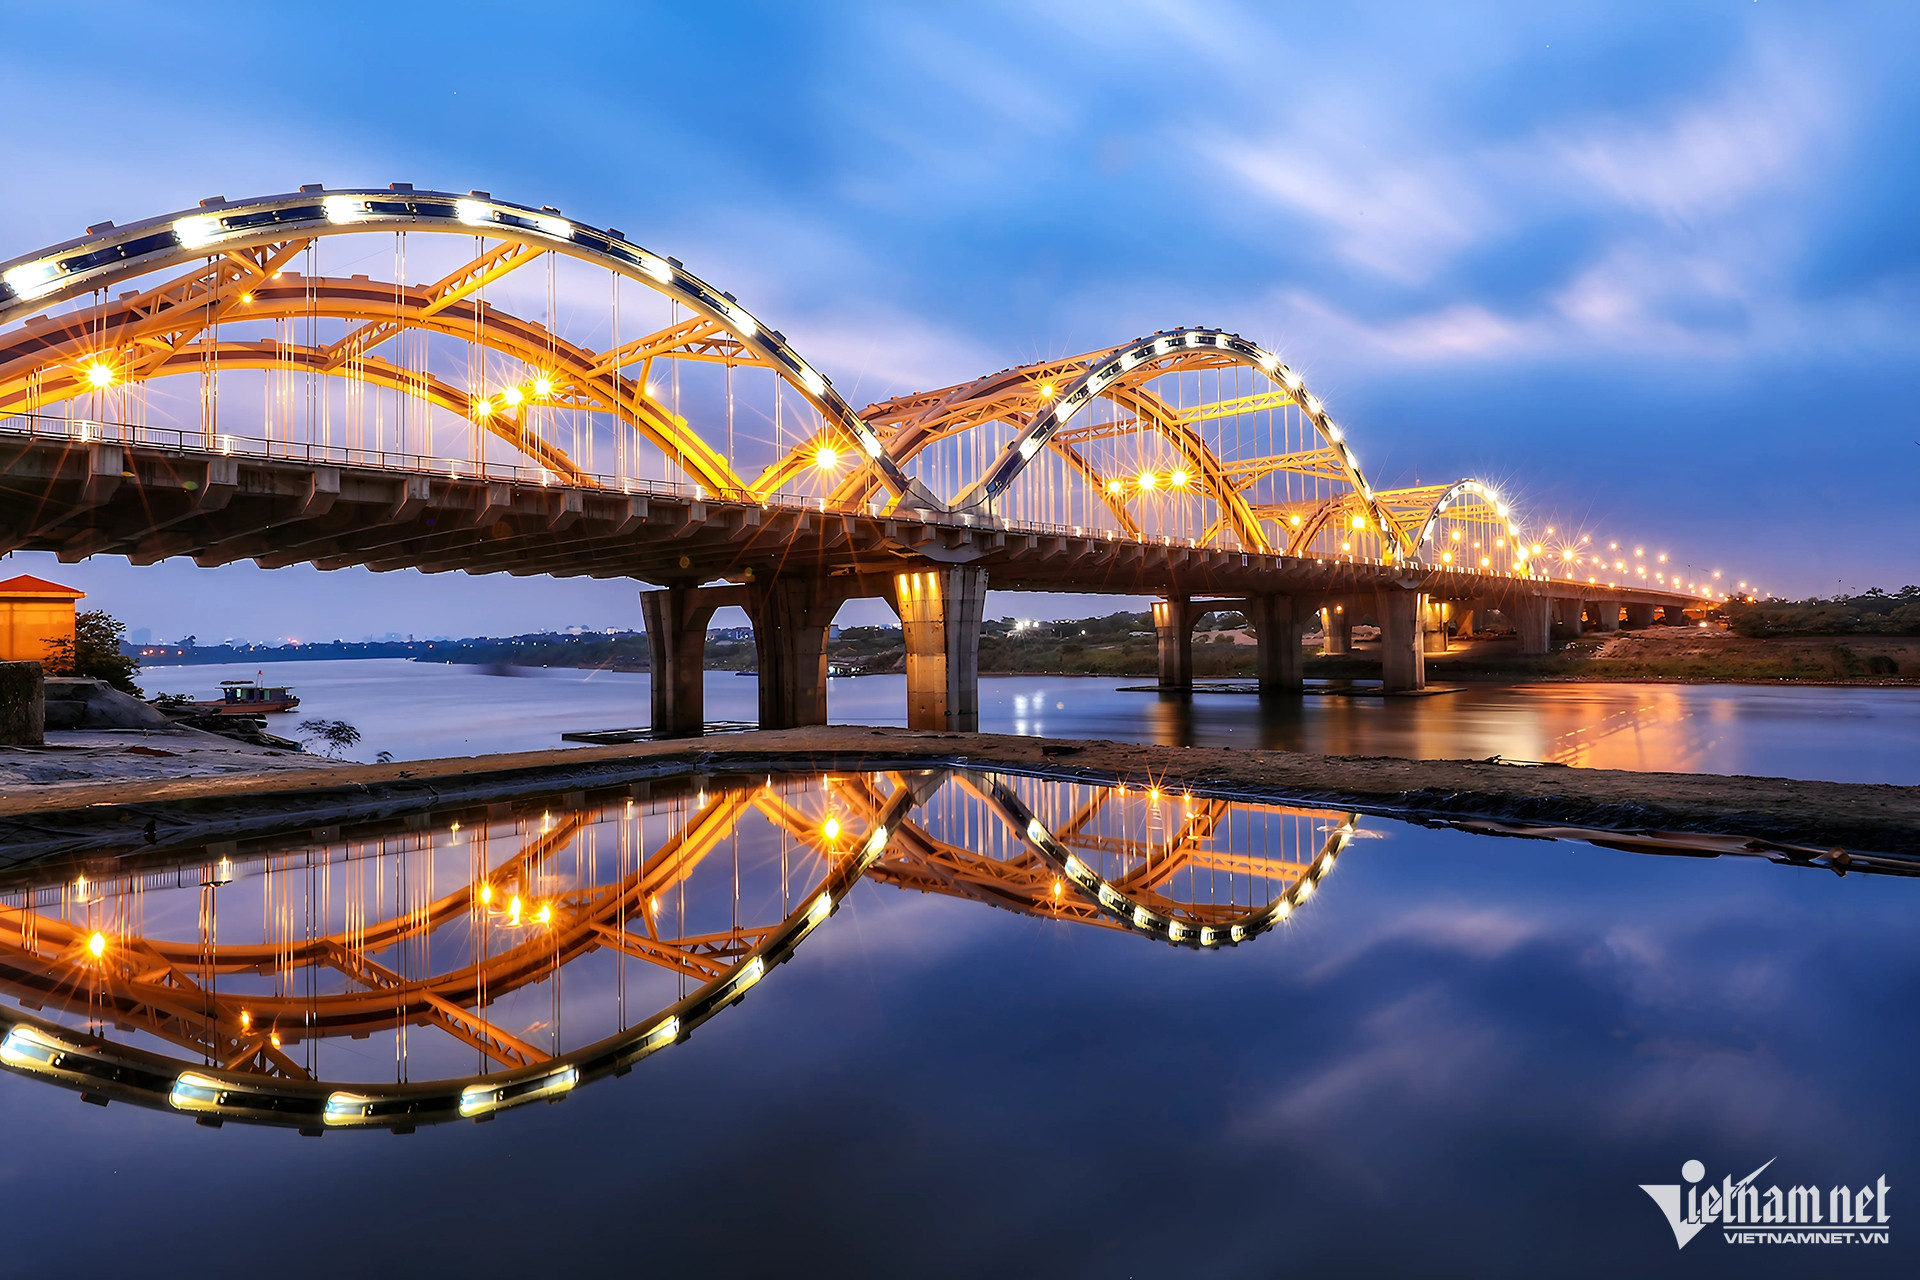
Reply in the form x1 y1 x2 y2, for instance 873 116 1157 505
0 725 1920 869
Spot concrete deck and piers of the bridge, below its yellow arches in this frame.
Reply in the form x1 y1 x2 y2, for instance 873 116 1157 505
0 438 1699 733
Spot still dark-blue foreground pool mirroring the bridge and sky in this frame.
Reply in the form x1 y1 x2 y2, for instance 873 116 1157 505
0 767 1920 1276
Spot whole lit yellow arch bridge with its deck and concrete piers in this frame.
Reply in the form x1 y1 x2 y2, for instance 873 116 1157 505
0 184 1722 733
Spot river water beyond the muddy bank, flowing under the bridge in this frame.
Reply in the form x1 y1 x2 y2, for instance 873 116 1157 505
142 658 1920 785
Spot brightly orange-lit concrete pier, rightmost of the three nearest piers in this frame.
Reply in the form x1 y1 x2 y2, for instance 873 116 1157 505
895 568 987 733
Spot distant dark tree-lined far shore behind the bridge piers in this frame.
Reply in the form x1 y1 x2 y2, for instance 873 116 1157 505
129 587 1920 685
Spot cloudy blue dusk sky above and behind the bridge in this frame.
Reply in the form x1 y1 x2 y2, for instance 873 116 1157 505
0 0 1920 639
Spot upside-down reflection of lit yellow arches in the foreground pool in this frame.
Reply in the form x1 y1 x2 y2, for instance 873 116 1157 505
0 770 1357 1134
